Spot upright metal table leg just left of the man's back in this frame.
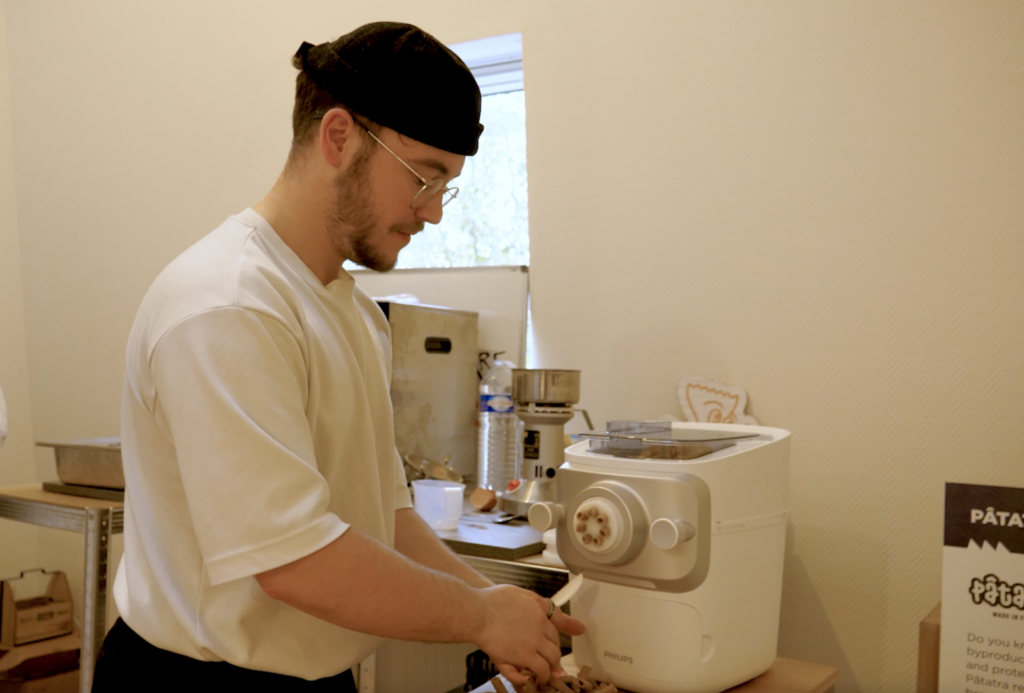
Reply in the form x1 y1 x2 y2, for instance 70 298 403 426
79 508 113 693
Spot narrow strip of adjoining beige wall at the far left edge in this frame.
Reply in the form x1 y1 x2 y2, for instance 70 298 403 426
0 4 39 578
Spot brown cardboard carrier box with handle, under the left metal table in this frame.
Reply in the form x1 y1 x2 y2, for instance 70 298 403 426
0 569 75 650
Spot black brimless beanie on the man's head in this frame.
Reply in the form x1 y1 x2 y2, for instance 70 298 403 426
295 21 483 157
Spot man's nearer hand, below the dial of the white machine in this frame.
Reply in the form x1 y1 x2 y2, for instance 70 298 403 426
473 584 585 685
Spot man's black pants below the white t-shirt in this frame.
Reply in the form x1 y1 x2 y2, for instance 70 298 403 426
92 618 356 693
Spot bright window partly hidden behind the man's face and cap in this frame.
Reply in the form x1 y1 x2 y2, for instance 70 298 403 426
395 34 529 268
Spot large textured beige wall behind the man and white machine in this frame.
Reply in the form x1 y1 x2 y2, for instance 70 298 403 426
0 0 1024 693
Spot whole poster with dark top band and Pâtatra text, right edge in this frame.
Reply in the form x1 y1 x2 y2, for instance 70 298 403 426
939 483 1024 693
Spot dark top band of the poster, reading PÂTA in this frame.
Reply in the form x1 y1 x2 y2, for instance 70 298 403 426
943 483 1024 554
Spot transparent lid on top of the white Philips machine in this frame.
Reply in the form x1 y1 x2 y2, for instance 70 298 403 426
580 421 758 460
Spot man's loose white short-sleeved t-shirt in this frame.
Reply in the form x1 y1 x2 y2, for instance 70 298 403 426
114 209 412 680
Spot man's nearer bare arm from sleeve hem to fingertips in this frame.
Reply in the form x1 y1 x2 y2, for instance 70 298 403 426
256 527 584 683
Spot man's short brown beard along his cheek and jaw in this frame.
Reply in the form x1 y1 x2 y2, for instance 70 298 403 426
328 147 398 272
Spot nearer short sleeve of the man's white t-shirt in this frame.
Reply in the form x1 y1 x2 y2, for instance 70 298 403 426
149 307 348 584
